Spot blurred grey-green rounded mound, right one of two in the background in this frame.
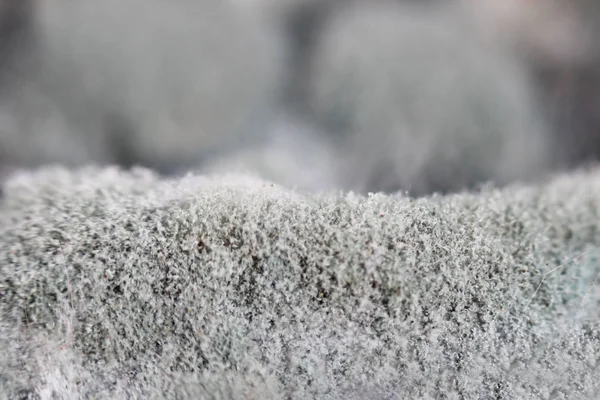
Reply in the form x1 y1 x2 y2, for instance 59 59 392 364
309 3 548 194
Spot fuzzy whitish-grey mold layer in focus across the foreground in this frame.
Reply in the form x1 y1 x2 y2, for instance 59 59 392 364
0 168 600 399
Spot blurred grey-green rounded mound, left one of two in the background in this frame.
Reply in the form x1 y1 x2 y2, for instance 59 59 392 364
0 0 283 169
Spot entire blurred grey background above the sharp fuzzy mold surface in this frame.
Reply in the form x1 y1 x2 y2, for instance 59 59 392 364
0 0 600 196
